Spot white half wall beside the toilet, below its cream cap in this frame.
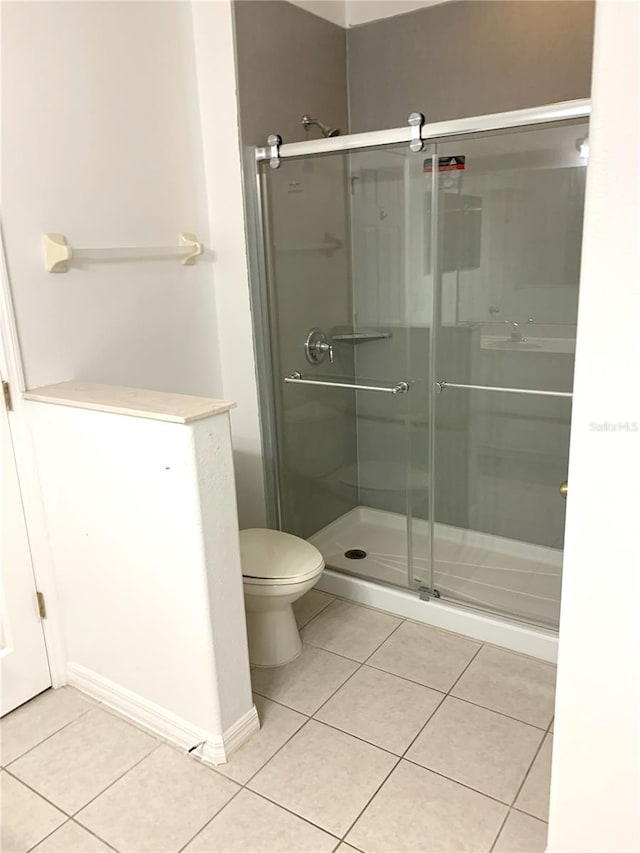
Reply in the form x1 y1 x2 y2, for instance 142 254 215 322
26 398 257 761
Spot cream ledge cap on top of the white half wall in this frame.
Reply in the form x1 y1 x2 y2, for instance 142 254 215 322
22 382 236 424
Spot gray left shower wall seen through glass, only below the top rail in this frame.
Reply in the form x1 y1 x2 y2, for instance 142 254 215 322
262 150 357 539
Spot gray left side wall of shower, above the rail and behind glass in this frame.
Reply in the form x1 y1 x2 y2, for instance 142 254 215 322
234 0 357 537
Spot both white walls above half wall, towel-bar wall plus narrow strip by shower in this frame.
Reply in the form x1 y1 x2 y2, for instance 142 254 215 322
1 0 265 527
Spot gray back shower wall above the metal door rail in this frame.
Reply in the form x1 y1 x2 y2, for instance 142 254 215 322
347 0 595 133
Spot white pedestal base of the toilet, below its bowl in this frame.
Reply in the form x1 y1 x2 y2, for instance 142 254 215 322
247 599 302 667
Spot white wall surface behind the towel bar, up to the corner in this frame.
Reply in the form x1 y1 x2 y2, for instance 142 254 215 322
2 1 222 396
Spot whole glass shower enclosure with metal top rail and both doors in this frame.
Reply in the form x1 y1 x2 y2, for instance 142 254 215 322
249 101 589 629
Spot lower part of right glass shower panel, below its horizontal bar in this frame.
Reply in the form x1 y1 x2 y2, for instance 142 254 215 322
433 388 571 628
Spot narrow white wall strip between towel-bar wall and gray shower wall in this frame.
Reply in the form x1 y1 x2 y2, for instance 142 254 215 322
193 0 266 528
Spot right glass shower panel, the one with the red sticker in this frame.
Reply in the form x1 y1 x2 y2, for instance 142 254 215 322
433 124 587 627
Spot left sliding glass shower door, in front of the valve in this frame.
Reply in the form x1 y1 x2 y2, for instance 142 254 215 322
262 145 430 587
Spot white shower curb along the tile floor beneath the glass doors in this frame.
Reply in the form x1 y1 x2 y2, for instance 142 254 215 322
315 569 558 663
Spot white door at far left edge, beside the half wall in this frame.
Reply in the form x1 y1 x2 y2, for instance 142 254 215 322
0 376 51 716
